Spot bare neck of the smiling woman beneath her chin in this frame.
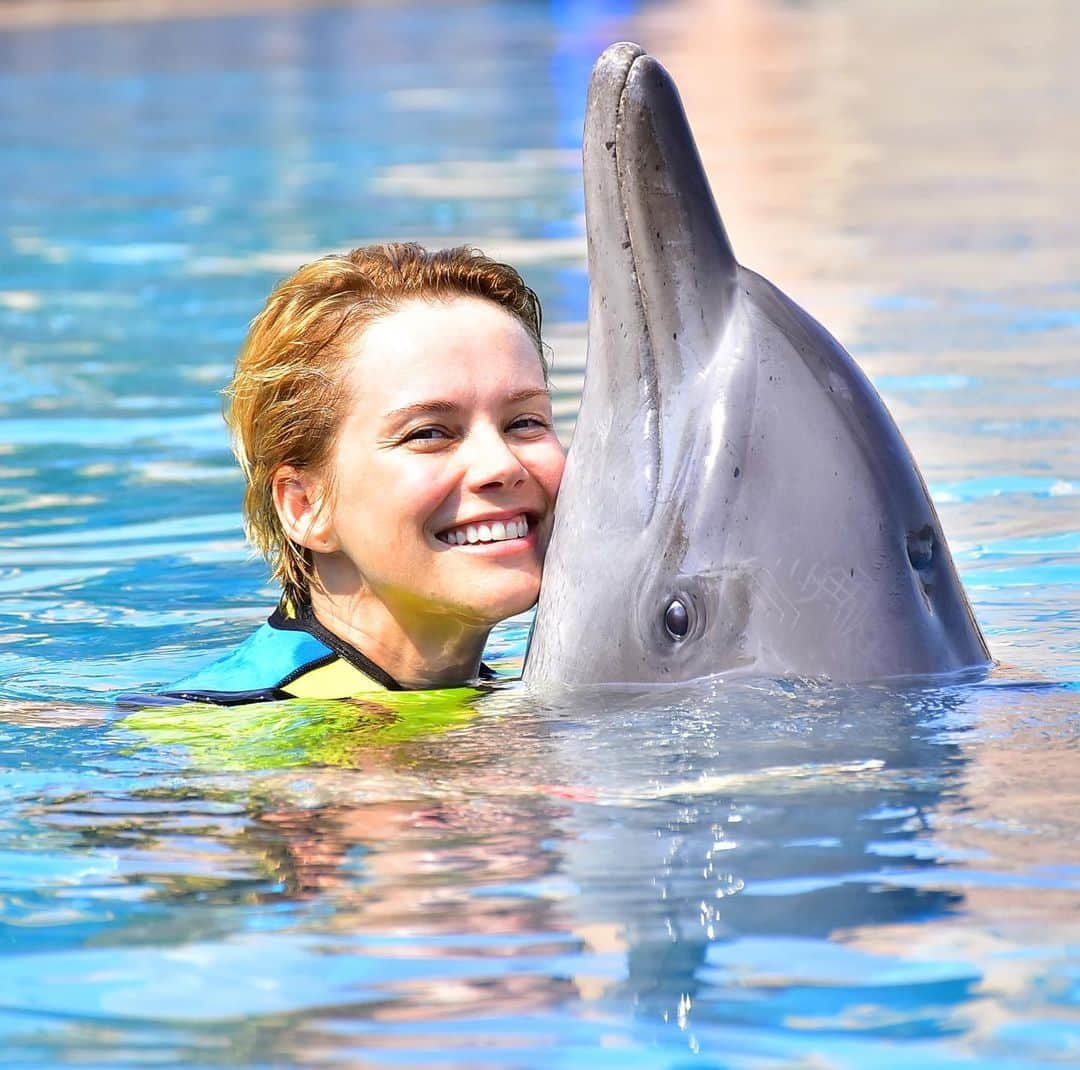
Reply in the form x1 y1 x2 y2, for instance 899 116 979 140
311 585 490 691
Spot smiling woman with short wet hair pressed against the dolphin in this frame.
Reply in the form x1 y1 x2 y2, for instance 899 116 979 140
140 244 563 705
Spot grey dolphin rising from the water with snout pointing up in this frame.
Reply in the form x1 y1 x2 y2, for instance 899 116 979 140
524 44 989 686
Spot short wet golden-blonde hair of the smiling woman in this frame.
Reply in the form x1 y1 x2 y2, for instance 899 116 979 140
225 242 548 605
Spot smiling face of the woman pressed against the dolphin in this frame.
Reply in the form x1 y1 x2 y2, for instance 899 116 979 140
311 297 564 626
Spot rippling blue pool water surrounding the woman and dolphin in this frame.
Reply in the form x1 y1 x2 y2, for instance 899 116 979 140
0 0 1080 1070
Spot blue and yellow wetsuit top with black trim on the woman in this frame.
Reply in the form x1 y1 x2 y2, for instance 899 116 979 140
117 600 495 707
